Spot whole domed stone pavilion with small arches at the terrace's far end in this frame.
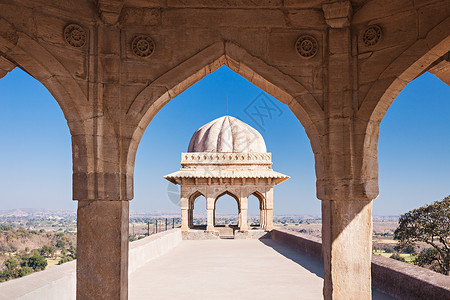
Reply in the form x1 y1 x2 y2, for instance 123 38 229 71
164 116 289 232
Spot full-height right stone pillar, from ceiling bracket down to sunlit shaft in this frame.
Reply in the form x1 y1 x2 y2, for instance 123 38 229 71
316 1 378 300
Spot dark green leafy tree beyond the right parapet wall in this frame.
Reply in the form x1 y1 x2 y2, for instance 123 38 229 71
394 196 450 275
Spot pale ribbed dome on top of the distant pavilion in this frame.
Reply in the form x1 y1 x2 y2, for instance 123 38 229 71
188 116 267 153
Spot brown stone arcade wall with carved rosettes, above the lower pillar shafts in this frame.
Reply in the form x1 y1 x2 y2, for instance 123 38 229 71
0 0 450 299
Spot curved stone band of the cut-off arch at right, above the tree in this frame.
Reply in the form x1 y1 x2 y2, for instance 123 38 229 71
356 17 450 185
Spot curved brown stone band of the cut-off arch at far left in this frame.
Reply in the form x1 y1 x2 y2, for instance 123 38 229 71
0 17 94 199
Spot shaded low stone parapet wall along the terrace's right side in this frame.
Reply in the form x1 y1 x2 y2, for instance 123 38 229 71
271 228 450 300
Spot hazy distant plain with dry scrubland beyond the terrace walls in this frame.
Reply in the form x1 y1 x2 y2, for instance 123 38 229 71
0 209 442 281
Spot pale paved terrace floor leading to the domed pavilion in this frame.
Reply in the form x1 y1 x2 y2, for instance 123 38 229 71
129 240 393 300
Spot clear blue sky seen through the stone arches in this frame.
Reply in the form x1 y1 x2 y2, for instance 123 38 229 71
0 67 450 215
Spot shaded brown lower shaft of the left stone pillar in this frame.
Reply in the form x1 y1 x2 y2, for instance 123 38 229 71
77 200 129 300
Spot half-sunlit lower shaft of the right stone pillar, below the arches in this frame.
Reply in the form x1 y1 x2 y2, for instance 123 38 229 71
322 200 372 299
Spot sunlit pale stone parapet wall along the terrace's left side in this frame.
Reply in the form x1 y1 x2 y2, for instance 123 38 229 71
0 228 181 300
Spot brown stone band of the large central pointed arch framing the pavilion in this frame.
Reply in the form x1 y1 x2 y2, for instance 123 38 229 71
126 41 326 183
